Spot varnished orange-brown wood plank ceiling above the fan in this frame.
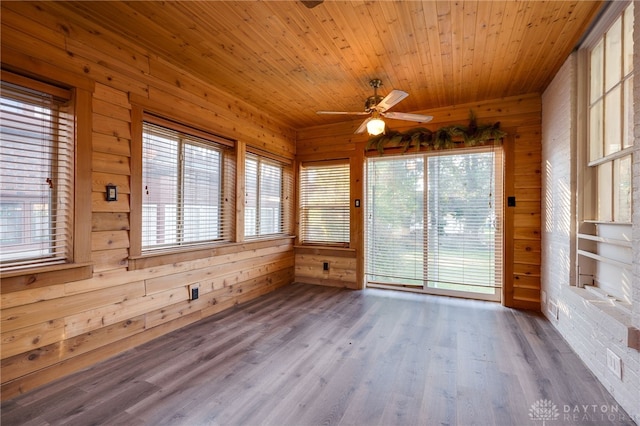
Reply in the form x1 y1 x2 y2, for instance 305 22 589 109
47 1 604 129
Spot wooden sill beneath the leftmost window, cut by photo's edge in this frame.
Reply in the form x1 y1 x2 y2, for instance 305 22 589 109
0 262 93 293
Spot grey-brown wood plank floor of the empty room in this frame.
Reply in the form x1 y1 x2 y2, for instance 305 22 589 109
1 284 634 426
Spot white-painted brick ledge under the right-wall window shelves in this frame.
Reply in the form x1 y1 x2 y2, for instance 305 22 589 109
571 286 640 351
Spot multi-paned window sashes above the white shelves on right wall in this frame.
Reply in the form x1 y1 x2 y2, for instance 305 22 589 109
587 3 633 223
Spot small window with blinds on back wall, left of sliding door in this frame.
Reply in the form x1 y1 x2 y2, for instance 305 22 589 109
300 161 350 247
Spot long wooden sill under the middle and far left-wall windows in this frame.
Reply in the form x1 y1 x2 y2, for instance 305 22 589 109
129 235 294 271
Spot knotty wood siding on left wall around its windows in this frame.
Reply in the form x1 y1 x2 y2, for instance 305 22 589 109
1 2 295 399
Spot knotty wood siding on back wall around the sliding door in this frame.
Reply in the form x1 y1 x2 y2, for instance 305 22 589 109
295 94 541 310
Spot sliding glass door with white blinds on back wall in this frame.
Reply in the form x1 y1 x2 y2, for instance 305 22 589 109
365 147 502 300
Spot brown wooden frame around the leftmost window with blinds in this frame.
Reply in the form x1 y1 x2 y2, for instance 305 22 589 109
0 66 95 284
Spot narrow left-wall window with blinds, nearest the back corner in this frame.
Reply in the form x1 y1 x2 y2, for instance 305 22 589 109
244 153 291 238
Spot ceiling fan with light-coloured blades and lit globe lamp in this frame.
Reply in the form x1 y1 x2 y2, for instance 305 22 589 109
317 79 433 135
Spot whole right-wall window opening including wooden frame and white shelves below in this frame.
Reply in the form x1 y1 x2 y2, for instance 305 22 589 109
578 2 634 302
